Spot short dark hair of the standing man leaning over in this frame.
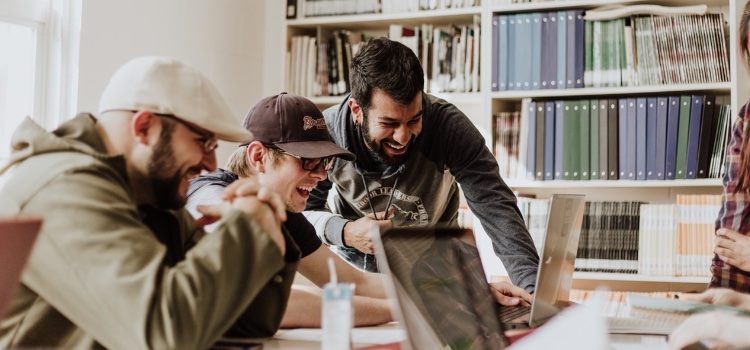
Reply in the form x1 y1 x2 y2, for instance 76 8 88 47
349 37 424 111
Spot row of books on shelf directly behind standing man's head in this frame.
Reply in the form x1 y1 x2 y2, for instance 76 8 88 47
287 20 481 96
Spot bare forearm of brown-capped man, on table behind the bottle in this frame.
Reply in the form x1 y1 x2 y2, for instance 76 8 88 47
281 286 393 328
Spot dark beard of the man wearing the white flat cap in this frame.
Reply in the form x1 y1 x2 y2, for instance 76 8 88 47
148 127 187 209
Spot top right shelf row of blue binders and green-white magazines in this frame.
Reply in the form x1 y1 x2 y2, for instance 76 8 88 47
491 9 730 91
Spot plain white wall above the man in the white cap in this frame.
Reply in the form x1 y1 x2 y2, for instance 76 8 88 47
78 0 274 165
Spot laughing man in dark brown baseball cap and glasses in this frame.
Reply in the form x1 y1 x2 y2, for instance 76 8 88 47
187 92 392 328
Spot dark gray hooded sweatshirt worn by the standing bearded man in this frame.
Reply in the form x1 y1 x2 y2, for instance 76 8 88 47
305 94 539 291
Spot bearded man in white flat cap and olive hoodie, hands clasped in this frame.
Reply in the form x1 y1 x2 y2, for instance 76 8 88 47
0 57 300 349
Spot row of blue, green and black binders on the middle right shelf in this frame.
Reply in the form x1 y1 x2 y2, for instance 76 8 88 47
494 95 732 181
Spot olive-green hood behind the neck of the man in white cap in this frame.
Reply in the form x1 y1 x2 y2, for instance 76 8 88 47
0 113 125 174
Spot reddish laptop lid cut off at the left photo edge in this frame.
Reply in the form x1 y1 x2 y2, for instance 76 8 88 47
0 218 42 320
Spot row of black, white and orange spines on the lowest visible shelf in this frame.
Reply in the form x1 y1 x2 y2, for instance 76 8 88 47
518 195 721 276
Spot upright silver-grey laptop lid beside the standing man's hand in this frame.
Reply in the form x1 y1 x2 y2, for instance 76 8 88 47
529 194 586 327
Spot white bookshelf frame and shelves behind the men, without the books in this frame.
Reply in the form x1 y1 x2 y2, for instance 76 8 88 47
274 0 750 291
